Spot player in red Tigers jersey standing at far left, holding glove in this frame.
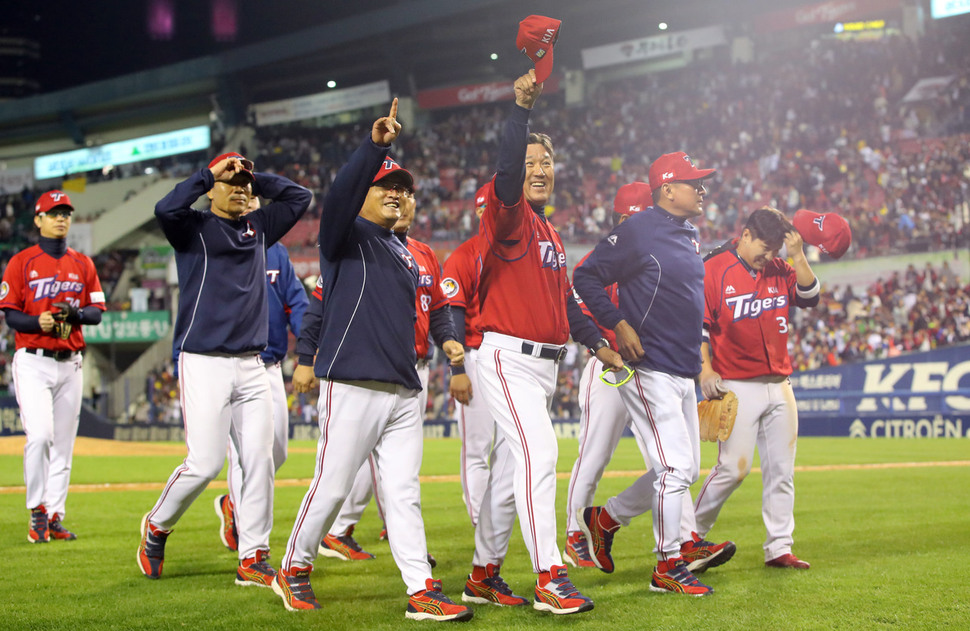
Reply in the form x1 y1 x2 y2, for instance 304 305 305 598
0 191 105 543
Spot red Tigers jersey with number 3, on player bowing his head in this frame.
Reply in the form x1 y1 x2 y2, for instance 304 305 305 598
704 249 797 379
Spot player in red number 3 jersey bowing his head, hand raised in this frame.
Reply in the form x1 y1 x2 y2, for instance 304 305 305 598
694 208 819 570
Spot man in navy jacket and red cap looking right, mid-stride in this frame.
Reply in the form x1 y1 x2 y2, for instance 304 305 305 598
573 152 735 596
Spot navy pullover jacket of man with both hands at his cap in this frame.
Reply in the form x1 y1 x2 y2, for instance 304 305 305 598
155 169 312 355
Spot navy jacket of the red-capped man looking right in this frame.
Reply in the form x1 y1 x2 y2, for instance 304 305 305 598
573 206 704 378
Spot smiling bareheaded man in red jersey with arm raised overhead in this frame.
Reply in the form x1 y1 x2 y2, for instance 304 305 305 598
465 70 593 614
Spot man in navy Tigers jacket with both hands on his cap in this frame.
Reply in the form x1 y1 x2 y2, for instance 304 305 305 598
138 153 312 587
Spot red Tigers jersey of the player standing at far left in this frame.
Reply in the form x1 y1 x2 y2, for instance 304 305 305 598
0 245 105 351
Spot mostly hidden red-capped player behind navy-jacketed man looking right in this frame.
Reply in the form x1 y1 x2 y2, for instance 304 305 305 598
564 182 652 567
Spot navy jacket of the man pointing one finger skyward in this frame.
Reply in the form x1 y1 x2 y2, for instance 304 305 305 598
304 138 421 390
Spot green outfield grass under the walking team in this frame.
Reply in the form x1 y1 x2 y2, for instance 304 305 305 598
0 438 970 631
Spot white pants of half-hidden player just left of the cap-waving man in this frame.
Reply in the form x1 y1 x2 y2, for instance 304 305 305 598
456 348 496 526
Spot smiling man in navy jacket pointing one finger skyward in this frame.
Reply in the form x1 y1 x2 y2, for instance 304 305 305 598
273 99 472 620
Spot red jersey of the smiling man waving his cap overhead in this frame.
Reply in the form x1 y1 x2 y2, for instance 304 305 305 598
478 180 569 344
